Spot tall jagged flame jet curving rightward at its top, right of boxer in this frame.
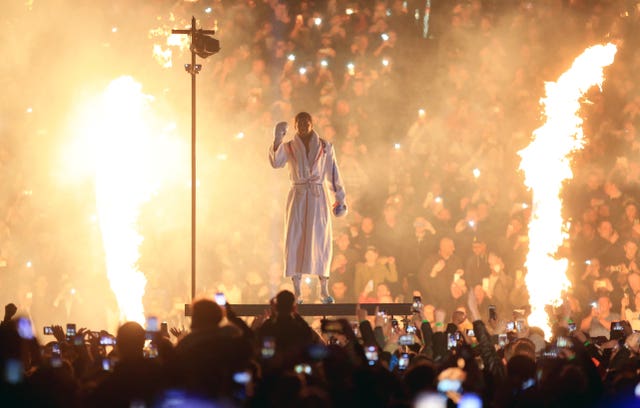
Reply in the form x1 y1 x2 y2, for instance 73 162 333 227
519 44 616 337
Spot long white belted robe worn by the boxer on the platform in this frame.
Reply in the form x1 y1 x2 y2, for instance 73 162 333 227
269 131 345 277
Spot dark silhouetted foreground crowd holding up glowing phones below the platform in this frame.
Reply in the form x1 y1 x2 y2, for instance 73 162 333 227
0 290 640 408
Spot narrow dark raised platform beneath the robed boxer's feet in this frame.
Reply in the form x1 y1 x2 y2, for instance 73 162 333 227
184 303 412 316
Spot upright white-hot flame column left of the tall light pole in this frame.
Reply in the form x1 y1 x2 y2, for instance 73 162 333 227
94 77 160 323
